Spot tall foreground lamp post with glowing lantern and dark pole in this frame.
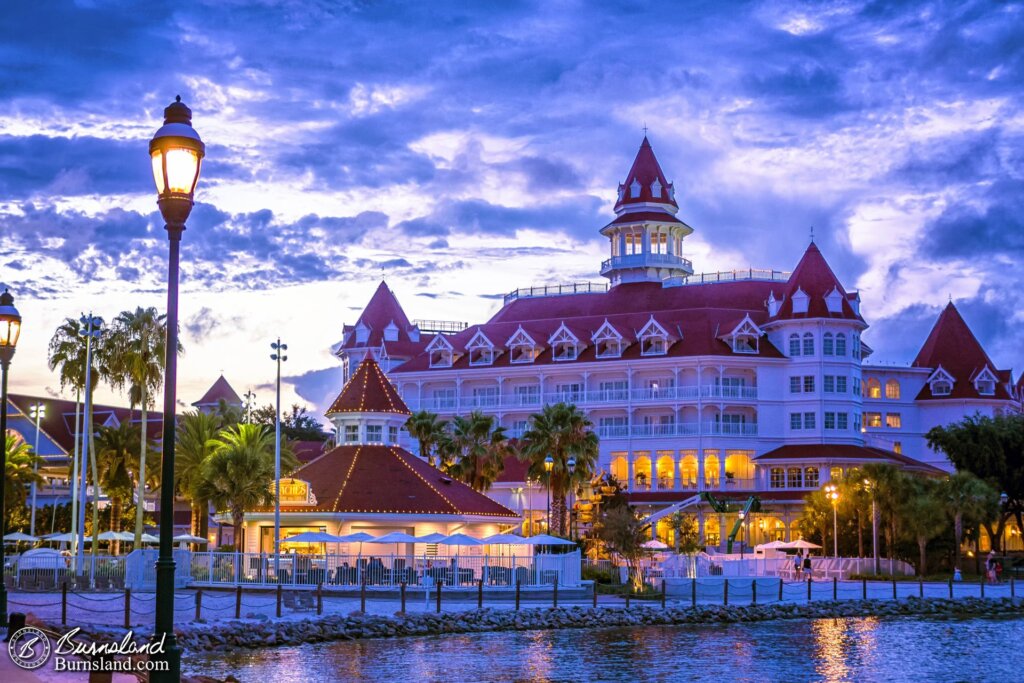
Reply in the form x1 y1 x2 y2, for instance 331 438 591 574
150 95 203 681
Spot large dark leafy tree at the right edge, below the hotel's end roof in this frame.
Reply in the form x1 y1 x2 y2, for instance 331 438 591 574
925 414 1024 550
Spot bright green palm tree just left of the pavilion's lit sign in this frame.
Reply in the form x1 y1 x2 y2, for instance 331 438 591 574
200 424 298 550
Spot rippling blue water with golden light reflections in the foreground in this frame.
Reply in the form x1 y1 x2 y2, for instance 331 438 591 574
184 617 1024 683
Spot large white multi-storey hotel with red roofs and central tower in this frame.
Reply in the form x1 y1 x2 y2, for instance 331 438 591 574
335 138 1022 545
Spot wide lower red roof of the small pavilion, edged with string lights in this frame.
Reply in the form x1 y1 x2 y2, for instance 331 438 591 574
283 445 518 519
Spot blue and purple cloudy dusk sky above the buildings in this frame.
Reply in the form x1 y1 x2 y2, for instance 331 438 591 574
0 0 1024 412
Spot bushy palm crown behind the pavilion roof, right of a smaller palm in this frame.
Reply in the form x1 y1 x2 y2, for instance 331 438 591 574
440 411 511 492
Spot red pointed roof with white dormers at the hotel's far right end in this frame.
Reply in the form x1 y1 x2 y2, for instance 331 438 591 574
912 301 1011 400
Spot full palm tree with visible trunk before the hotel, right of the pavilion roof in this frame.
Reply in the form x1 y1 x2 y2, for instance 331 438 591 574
521 403 598 536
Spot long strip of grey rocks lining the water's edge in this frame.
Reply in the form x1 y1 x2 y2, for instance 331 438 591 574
54 598 1024 652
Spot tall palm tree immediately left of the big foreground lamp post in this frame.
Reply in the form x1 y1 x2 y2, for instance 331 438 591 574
105 306 183 545
